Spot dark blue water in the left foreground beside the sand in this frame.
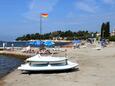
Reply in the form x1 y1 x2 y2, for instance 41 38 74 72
0 55 23 78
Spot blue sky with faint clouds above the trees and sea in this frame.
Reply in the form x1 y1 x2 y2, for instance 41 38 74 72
0 0 115 40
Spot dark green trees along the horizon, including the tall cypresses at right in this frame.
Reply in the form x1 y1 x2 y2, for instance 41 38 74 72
16 22 115 41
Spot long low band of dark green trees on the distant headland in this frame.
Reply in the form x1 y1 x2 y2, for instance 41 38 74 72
16 30 97 41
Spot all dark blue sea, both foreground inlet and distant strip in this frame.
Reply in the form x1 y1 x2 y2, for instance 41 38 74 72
0 41 69 78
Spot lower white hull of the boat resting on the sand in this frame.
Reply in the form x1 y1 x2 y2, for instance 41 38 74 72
18 61 78 71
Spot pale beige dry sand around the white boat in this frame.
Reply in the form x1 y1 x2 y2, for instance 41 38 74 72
3 43 115 86
